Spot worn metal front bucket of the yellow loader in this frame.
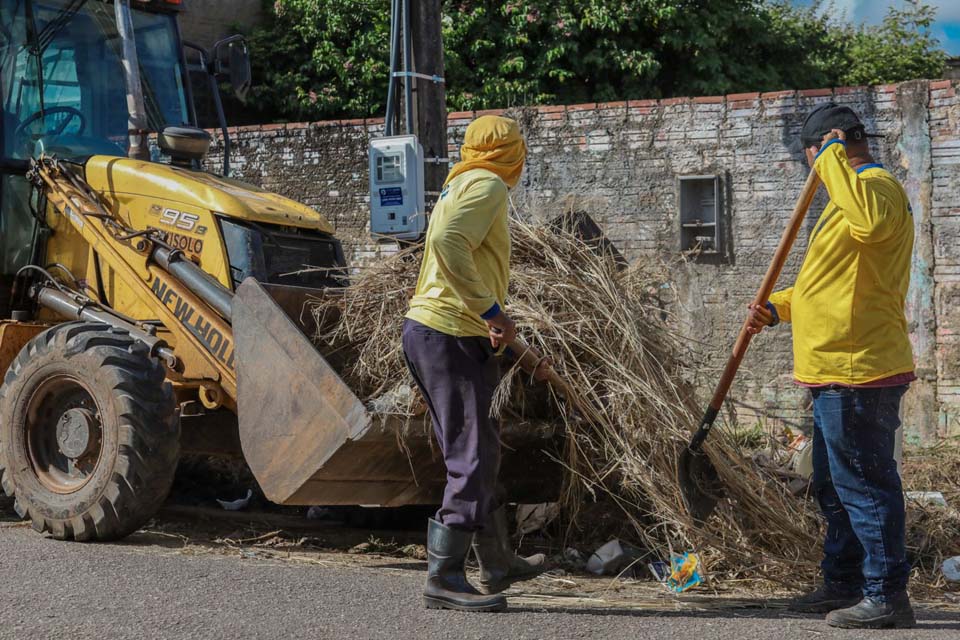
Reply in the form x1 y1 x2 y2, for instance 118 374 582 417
233 279 562 506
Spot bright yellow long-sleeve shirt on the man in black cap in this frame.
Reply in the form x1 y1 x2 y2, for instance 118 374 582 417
770 140 914 384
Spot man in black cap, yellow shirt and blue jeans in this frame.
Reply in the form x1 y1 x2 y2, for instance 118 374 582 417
750 103 916 628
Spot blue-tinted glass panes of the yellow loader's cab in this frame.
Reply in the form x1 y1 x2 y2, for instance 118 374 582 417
0 0 195 159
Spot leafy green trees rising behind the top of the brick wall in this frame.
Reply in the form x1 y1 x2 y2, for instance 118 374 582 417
244 0 946 119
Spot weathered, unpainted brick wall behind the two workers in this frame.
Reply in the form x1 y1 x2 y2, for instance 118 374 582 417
211 81 960 439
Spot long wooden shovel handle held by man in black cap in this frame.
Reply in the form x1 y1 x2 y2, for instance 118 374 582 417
690 169 820 451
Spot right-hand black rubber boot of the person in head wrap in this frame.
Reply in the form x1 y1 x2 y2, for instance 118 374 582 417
473 506 547 593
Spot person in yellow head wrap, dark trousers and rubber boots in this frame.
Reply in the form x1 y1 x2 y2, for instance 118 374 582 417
403 116 545 611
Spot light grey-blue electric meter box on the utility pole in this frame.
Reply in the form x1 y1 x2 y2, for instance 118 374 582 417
370 136 427 240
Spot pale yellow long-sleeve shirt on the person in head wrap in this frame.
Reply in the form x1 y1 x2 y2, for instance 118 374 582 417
407 169 510 336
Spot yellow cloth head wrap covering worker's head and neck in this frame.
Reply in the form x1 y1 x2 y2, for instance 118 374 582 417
443 116 527 189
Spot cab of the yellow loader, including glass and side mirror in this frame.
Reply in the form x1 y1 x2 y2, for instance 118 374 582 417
0 0 262 319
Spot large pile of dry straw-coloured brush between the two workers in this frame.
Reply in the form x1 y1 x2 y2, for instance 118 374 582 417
314 221 960 586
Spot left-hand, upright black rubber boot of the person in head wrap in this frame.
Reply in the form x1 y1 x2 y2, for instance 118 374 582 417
423 518 507 611
